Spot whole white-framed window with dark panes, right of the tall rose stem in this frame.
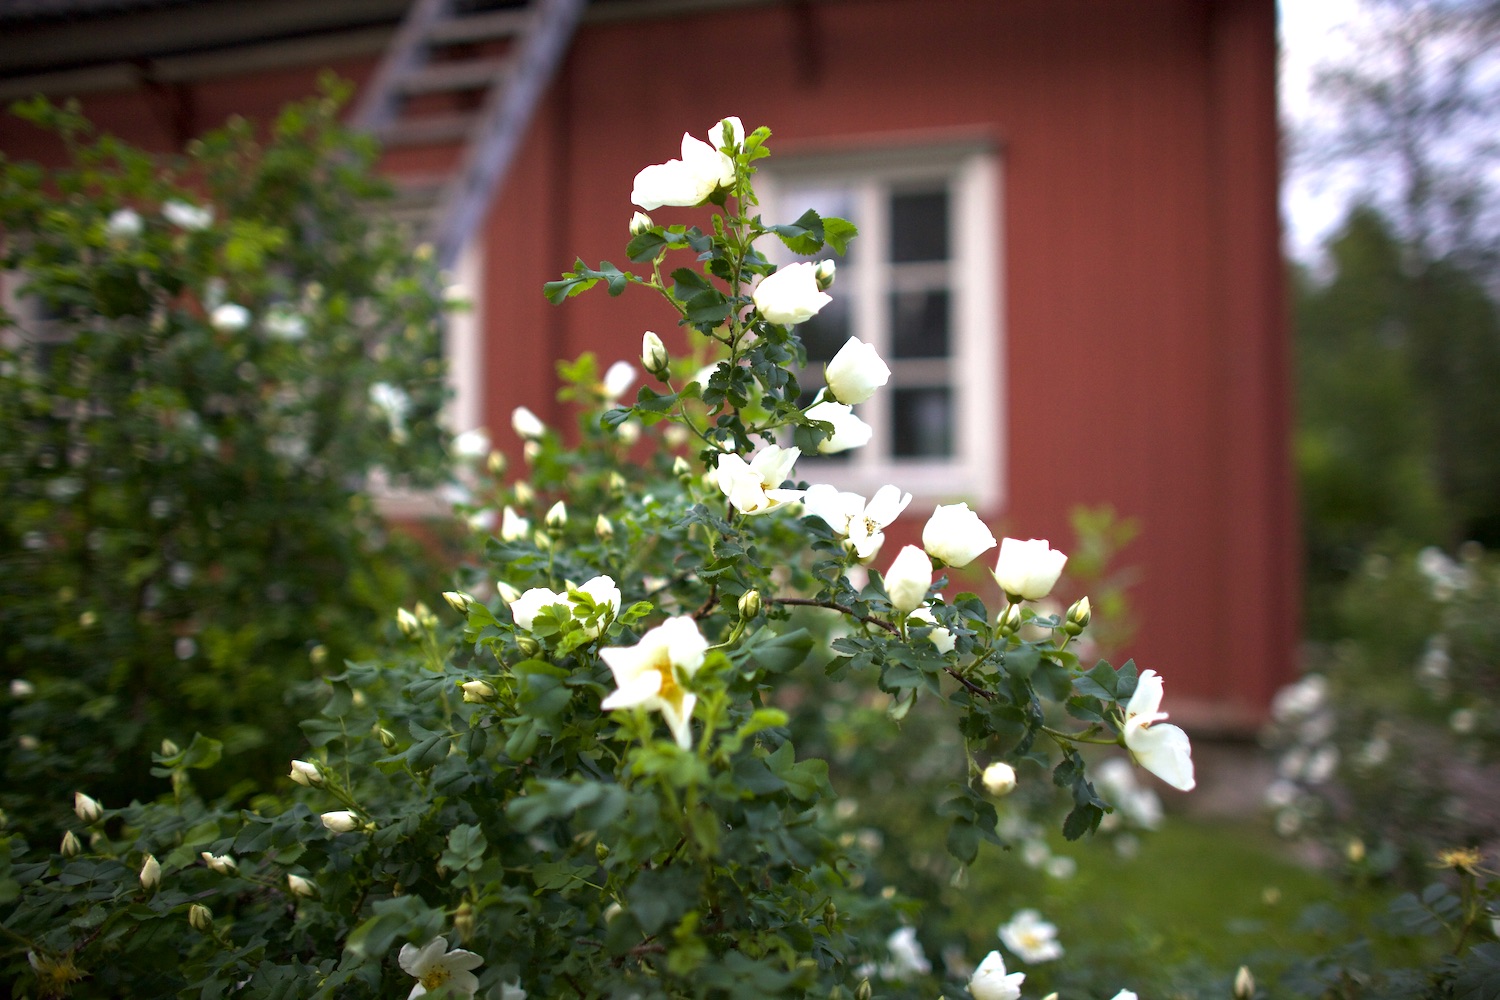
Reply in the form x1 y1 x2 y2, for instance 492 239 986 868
759 144 1004 507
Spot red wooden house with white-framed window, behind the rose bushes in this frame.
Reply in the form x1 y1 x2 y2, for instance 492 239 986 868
0 0 1298 732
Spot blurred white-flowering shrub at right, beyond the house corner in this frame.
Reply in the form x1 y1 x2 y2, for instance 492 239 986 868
1268 544 1500 885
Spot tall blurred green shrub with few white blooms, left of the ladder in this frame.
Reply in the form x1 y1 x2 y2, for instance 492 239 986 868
0 85 456 825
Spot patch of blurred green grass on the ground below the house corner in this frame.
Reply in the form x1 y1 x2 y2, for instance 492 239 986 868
942 819 1416 1000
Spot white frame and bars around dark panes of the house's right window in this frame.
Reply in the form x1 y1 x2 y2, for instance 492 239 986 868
756 141 1007 511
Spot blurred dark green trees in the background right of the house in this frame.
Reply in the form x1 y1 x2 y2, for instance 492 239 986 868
1295 208 1500 639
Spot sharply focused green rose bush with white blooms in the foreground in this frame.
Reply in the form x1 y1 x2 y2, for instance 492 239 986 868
0 118 1193 1000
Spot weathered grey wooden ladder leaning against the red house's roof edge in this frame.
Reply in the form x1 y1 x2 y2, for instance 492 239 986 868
351 0 588 267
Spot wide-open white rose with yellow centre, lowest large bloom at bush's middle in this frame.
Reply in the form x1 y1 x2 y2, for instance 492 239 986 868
599 615 708 750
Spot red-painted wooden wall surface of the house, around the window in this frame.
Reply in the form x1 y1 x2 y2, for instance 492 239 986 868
5 0 1298 726
